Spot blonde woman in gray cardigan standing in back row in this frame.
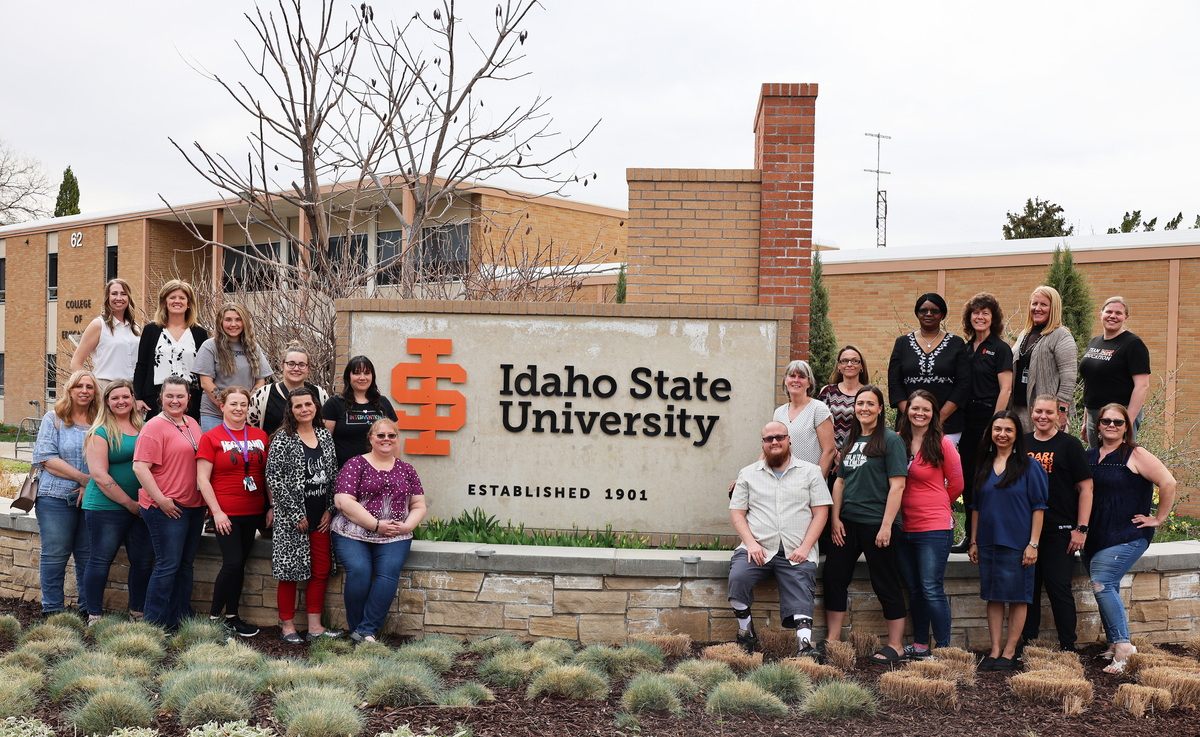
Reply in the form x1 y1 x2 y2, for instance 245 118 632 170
1012 284 1079 432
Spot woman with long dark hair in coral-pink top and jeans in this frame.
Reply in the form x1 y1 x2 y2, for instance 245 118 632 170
899 389 962 658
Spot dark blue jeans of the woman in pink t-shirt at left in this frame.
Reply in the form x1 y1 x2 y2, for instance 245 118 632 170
142 504 205 628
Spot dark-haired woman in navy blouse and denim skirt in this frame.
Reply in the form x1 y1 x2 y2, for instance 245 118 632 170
968 409 1050 671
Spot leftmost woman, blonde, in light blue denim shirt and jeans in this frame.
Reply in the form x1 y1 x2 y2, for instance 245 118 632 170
34 371 100 615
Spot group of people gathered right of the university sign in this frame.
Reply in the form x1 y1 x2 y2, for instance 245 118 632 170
728 286 1176 672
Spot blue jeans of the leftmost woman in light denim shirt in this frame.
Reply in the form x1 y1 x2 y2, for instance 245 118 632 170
34 497 89 613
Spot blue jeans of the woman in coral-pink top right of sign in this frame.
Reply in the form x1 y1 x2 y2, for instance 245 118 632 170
896 529 954 647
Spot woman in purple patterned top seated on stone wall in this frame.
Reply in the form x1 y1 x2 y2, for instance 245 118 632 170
330 418 425 642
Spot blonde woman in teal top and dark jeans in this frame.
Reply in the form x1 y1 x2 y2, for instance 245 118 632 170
83 379 154 623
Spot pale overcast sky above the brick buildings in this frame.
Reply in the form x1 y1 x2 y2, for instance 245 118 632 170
0 0 1200 248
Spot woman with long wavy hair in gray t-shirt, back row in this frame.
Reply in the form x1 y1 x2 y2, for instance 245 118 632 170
193 302 271 432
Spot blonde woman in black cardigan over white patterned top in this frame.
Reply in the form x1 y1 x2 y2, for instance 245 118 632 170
133 278 209 420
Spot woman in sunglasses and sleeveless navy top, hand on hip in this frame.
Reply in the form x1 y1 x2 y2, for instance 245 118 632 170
1084 402 1175 673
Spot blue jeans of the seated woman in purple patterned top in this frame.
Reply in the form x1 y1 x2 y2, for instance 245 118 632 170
332 533 413 636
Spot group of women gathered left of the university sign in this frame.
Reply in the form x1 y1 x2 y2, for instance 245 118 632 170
34 278 426 643
